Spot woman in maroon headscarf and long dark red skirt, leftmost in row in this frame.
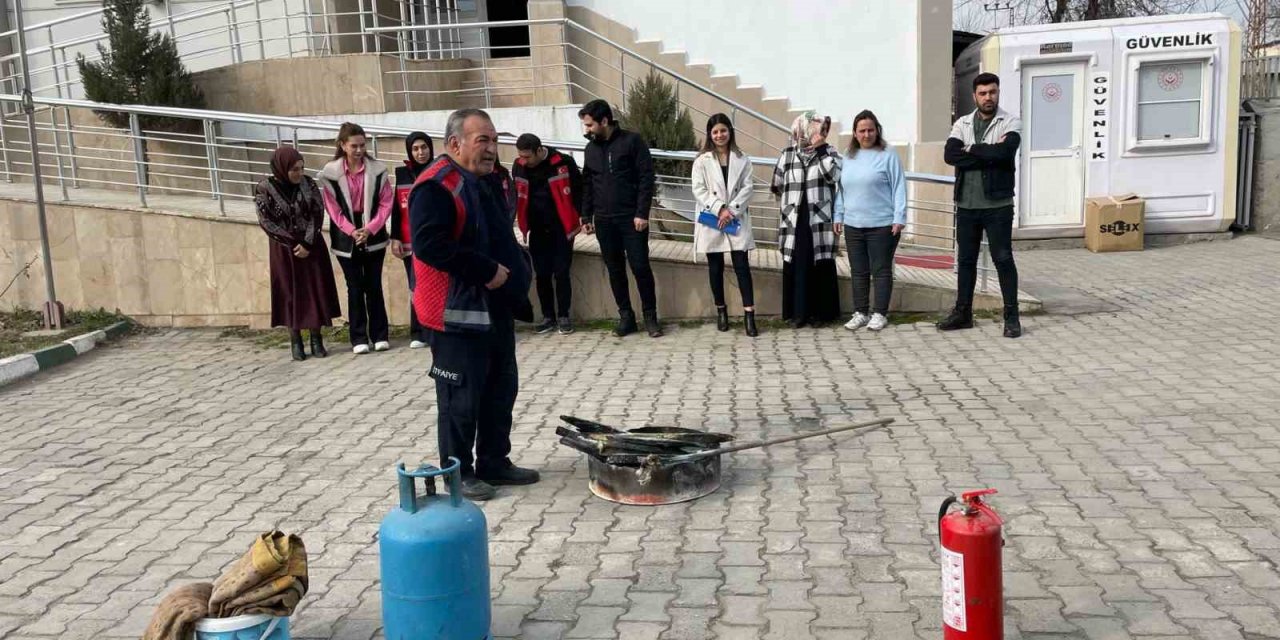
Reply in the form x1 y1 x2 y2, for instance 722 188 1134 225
253 147 342 360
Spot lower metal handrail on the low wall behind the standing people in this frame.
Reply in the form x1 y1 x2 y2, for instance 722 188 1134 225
0 93 989 291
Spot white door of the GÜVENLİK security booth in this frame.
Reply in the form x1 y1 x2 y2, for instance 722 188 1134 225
1019 64 1084 227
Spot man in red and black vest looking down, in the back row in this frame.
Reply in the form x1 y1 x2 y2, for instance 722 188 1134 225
512 133 582 334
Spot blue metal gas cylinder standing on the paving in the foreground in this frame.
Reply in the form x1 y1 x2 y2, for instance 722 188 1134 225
378 458 492 640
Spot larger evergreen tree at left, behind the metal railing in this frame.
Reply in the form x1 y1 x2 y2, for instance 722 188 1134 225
76 0 205 129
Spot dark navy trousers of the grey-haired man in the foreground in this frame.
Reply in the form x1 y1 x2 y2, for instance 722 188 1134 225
426 323 520 475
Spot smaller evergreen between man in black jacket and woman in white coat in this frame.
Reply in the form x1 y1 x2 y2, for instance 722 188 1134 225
618 70 698 178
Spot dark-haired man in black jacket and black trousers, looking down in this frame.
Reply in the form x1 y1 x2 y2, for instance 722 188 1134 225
577 100 662 338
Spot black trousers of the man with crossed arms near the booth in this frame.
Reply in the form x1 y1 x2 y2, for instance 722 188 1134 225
956 206 1018 307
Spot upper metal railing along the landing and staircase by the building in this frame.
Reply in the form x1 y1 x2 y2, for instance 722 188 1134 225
0 9 788 154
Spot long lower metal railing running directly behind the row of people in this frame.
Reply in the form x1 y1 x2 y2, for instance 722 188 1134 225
0 95 991 291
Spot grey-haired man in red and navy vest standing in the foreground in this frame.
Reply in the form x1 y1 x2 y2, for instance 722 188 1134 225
408 109 539 500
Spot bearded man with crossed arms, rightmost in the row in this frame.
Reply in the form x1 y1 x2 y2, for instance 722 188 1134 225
938 73 1023 338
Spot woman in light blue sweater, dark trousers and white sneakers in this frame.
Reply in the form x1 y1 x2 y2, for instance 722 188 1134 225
835 111 906 332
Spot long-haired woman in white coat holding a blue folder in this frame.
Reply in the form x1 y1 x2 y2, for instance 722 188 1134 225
692 114 759 338
